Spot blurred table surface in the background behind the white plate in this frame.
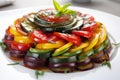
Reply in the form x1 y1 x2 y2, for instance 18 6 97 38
0 0 120 17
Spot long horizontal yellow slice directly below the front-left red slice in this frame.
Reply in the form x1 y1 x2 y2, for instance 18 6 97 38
36 40 65 49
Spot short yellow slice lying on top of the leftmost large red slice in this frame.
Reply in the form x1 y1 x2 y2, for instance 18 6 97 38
14 36 33 44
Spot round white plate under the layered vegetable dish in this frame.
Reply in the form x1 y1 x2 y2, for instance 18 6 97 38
0 6 120 80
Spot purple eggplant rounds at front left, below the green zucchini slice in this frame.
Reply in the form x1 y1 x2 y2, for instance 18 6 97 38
23 55 48 69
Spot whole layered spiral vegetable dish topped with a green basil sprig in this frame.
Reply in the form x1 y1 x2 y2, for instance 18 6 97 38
3 0 112 73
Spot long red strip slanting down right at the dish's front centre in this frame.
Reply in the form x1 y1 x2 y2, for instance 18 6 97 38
53 32 81 45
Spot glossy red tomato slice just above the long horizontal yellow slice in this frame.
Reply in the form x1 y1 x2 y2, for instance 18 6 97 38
29 30 48 43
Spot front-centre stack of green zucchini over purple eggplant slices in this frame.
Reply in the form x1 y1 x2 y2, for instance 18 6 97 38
49 56 77 73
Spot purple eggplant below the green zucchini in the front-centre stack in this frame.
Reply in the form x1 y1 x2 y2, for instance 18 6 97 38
49 62 76 73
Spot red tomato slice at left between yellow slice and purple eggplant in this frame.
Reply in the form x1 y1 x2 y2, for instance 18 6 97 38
11 41 33 51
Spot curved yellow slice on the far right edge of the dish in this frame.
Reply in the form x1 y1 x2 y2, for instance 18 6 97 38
95 25 107 47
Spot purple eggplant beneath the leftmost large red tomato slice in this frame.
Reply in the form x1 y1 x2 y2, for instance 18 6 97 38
9 48 27 59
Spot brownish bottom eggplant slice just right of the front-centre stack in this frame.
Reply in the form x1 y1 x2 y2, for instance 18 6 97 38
76 62 95 71
